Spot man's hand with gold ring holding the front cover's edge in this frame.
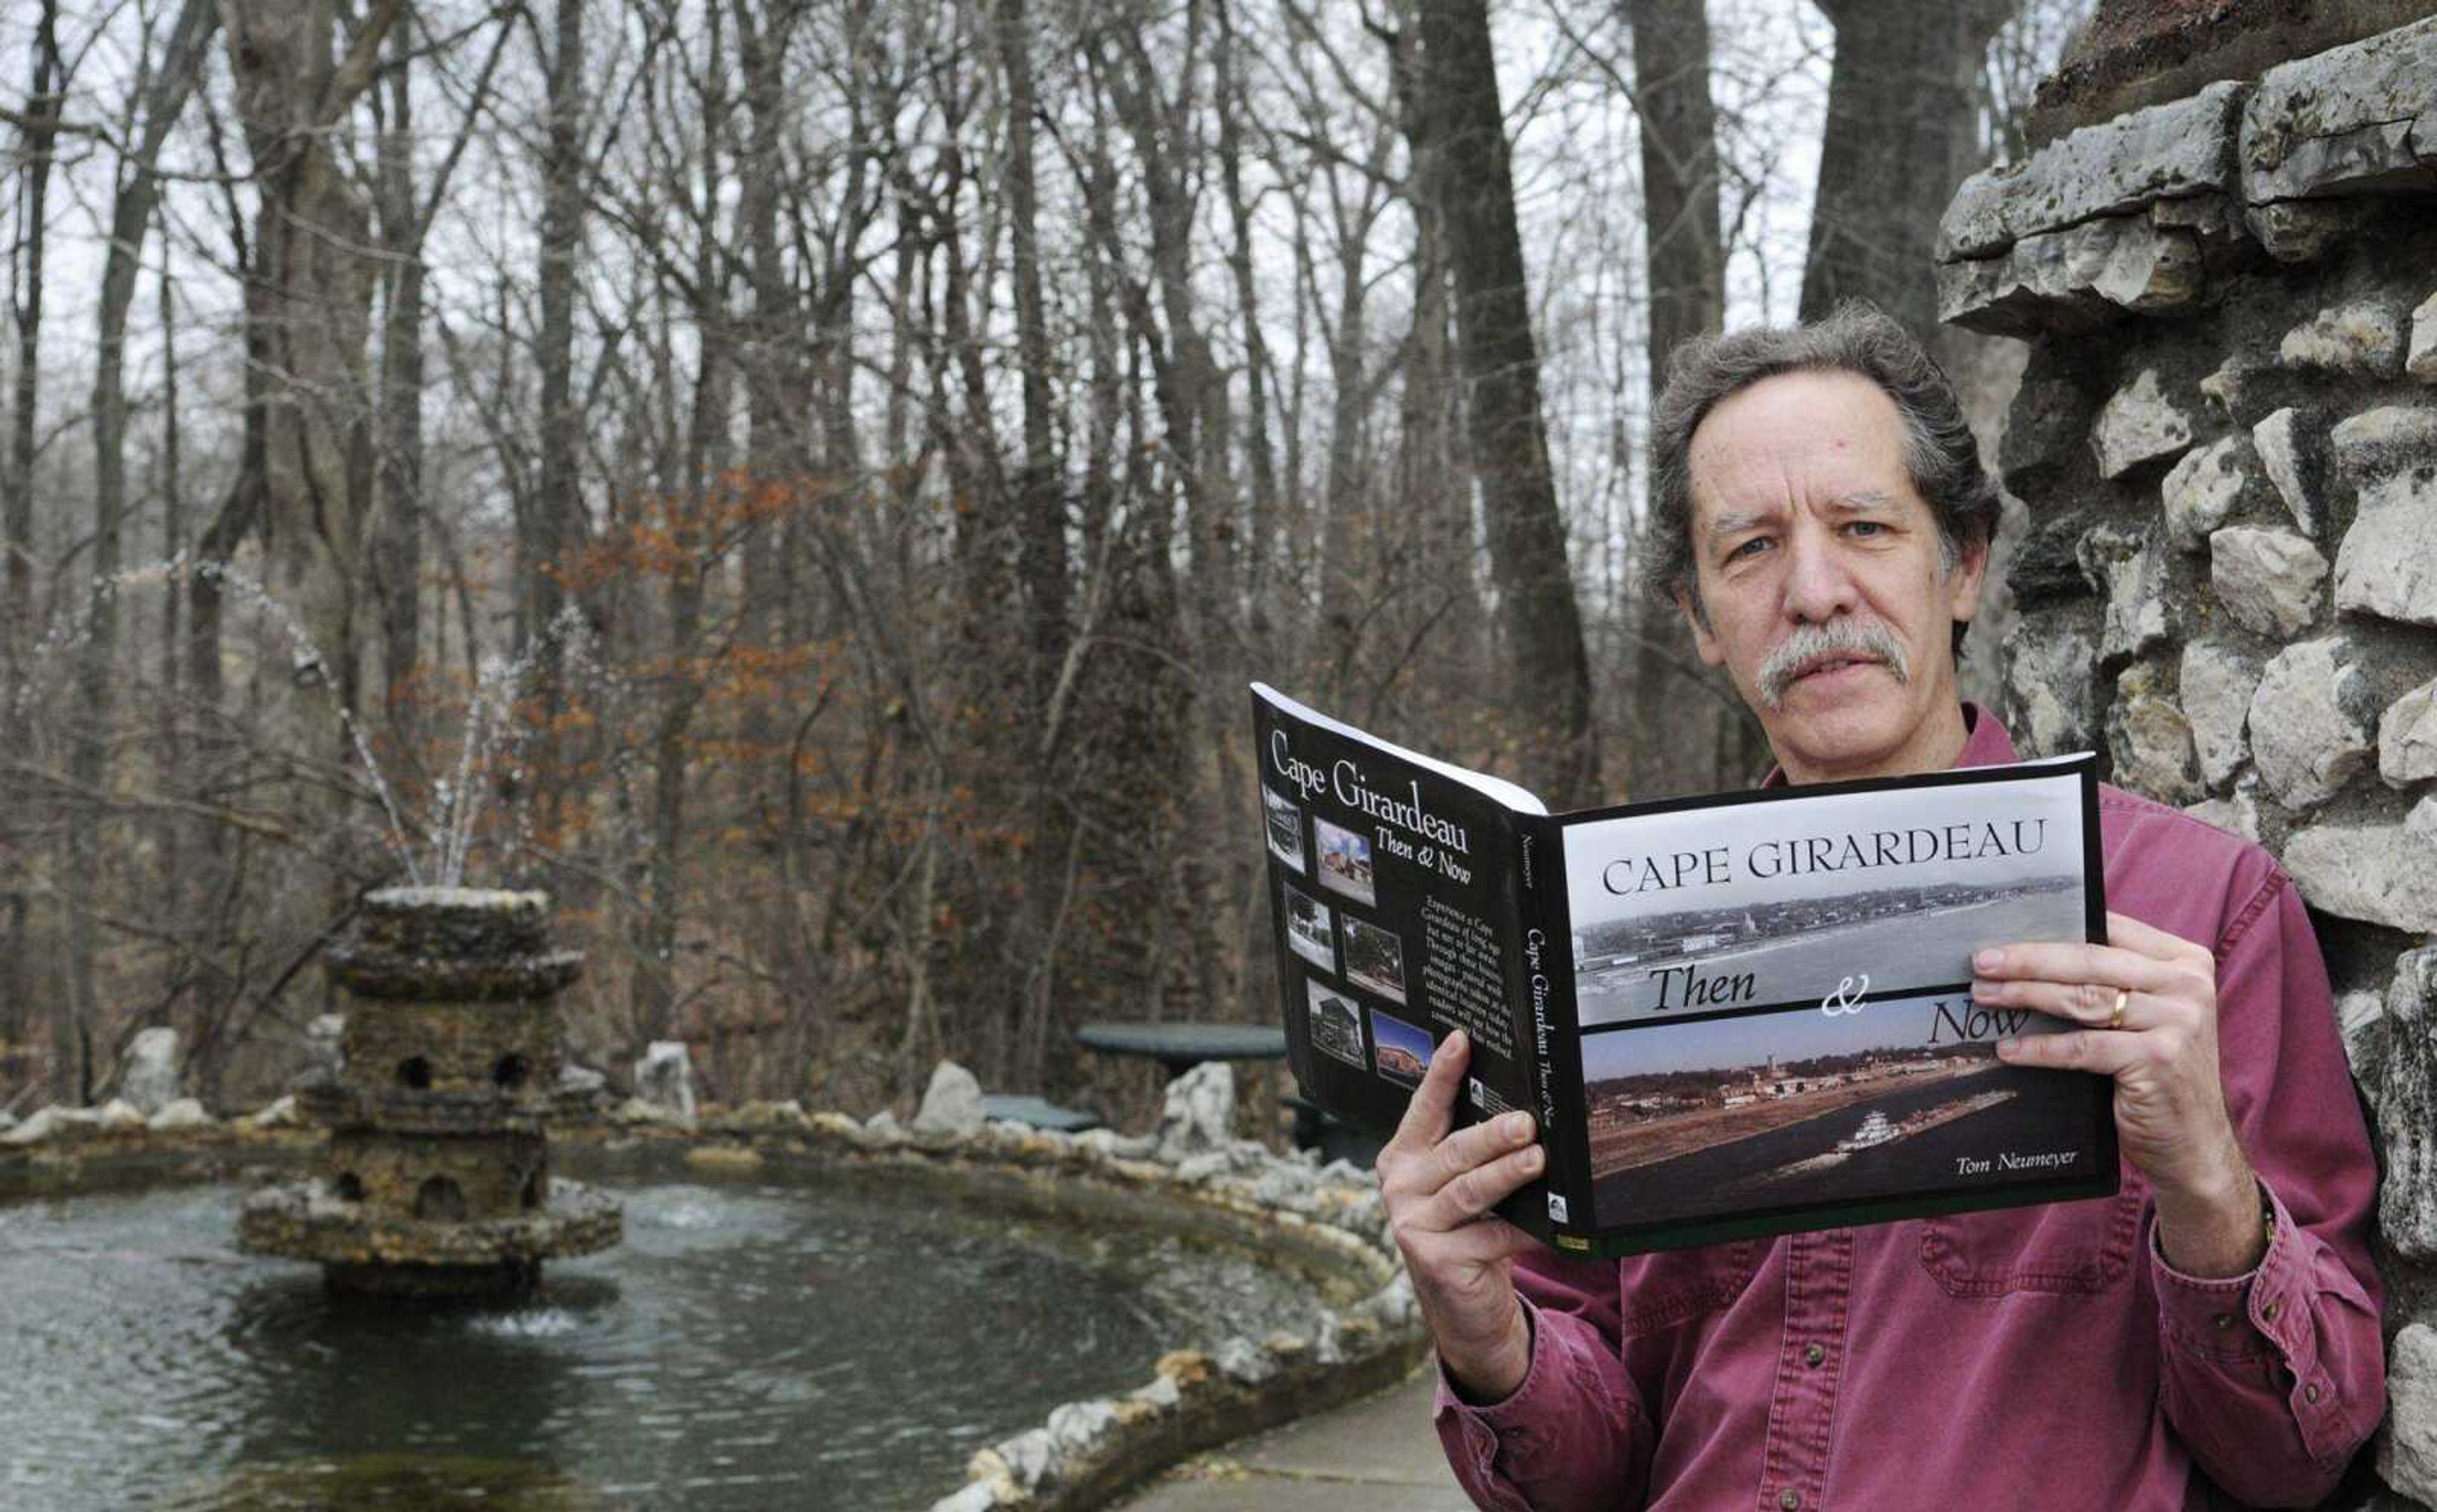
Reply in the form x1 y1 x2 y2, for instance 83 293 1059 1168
1972 913 2266 1276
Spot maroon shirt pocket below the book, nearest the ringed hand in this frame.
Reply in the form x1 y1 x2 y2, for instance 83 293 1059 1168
1920 1166 2150 1298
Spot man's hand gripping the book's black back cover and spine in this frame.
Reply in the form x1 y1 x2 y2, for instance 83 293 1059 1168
1379 1030 1545 1402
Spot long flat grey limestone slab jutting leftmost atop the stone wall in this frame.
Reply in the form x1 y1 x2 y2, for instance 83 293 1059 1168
1938 82 2245 263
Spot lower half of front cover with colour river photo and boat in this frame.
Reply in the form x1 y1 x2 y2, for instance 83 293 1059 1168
1582 994 2094 1225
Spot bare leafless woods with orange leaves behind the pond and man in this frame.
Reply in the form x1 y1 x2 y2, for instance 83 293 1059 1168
0 0 2079 1105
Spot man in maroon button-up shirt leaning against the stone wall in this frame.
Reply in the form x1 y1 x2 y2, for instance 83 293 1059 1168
1379 307 2386 1512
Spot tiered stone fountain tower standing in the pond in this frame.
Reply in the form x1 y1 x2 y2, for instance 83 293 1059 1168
239 886 624 1295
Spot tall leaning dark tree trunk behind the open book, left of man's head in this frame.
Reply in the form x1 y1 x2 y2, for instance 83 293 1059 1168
1421 0 1599 808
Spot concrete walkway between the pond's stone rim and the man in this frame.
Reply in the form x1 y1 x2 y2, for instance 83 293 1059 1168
1119 1369 1472 1512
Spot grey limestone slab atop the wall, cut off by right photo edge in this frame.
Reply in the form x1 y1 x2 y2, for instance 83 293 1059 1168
2240 20 2437 204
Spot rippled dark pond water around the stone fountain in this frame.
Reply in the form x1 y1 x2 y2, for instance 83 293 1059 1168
0 1154 1325 1512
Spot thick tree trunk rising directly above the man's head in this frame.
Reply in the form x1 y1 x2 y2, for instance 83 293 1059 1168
1801 0 2011 341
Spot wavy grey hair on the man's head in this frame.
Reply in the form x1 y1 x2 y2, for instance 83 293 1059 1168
1642 299 2001 623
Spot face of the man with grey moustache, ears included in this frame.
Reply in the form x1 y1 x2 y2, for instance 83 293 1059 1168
1684 372 1986 782
